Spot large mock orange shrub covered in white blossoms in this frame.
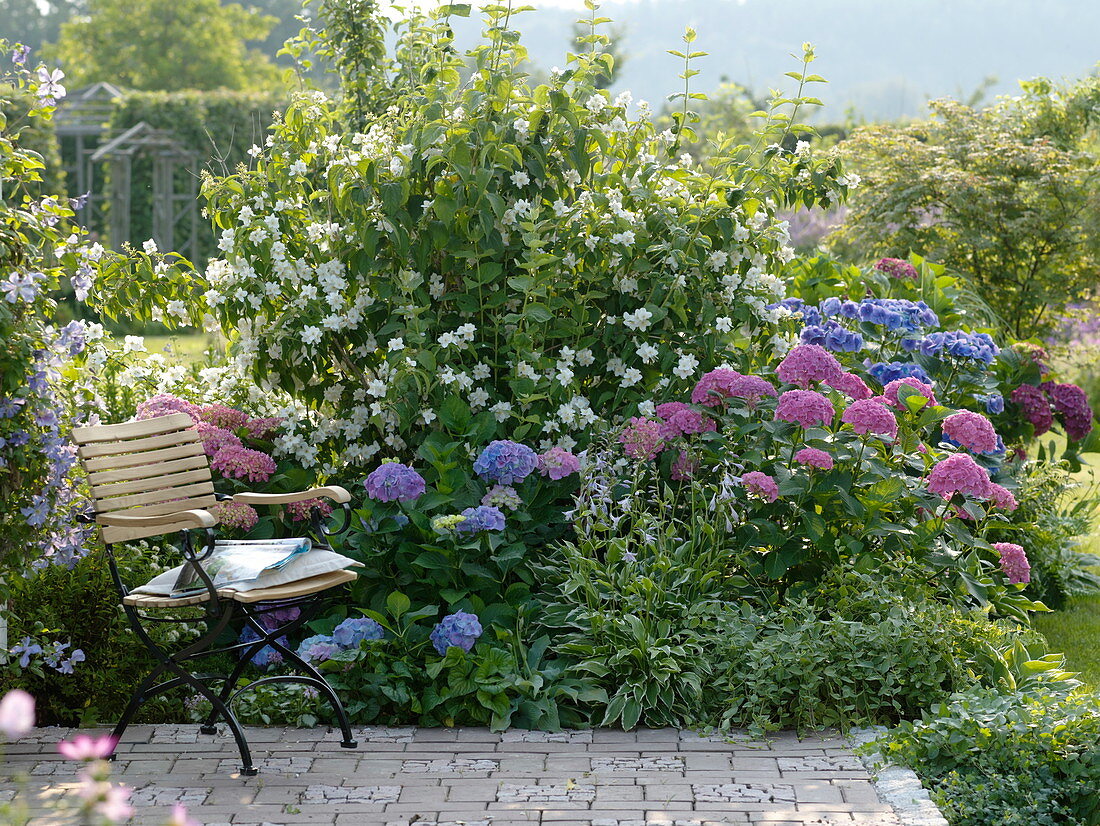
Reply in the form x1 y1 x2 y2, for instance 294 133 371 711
193 0 844 464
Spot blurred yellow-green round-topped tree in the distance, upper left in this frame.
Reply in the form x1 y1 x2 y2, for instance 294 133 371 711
53 0 278 91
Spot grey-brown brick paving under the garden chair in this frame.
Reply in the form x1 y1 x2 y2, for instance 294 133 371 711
0 726 900 826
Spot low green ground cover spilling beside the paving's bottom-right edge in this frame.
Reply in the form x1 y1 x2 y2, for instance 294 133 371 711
880 682 1100 826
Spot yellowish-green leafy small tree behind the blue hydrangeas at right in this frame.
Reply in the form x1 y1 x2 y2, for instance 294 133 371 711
833 77 1100 338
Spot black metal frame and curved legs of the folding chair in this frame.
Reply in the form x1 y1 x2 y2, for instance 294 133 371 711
89 495 359 777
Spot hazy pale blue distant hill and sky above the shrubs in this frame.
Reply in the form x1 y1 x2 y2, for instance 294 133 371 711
442 0 1100 120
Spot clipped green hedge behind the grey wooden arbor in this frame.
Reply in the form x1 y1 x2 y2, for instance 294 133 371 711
108 90 285 264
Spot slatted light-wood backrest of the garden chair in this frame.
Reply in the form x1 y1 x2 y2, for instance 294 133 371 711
73 414 216 543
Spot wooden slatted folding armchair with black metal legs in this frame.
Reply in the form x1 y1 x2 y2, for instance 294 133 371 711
73 414 365 775
